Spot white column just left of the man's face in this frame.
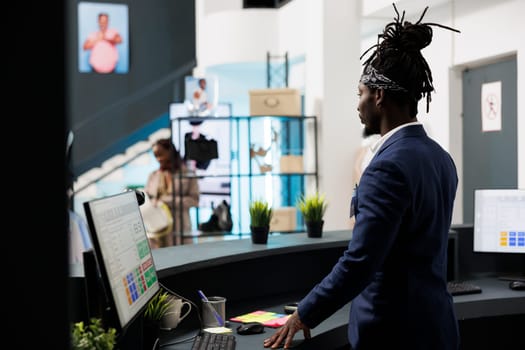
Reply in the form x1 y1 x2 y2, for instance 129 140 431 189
318 0 362 230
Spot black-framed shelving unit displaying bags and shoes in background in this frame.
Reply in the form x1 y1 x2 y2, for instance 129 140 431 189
171 116 318 241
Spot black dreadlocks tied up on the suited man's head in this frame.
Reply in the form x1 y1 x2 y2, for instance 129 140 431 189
360 4 459 117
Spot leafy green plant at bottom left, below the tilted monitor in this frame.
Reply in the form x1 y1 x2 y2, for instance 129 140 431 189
71 317 117 350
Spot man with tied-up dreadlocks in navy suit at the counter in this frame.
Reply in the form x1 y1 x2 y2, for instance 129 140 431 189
263 5 459 350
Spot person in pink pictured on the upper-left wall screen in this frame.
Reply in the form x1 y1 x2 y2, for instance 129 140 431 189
82 12 122 73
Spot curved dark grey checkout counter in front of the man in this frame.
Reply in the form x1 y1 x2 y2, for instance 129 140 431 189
149 231 525 350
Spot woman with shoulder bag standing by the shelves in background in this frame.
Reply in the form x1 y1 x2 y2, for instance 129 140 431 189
144 138 199 248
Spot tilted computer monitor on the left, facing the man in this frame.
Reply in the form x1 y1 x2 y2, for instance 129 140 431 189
84 191 160 330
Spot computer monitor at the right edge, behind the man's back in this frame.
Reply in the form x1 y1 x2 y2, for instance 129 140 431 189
473 189 525 254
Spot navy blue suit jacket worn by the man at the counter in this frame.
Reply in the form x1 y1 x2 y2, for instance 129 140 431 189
298 125 459 350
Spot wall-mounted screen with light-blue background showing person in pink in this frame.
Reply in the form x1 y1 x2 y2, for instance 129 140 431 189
78 2 129 74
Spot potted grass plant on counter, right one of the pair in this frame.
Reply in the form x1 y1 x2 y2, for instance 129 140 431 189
297 192 328 238
